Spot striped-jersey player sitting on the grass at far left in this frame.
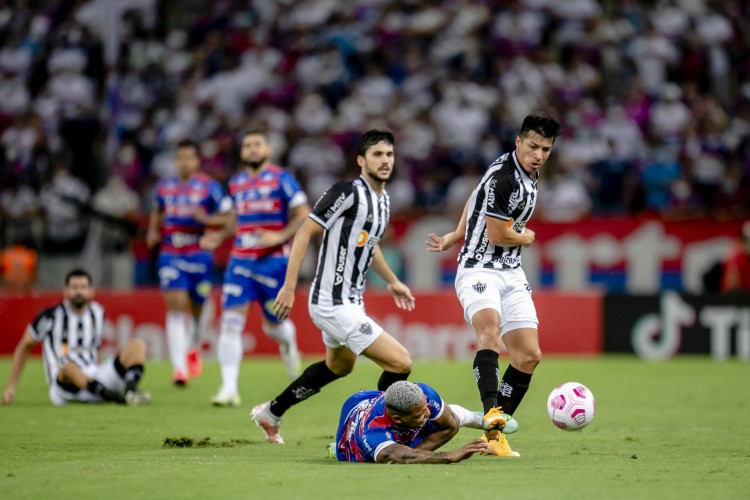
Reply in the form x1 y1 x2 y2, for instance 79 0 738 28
3 269 151 406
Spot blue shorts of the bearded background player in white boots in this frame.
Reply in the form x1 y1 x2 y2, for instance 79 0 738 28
221 257 287 323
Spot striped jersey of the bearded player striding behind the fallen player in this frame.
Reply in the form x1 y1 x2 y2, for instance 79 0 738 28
309 176 391 306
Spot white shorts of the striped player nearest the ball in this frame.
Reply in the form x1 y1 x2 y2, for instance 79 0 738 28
456 267 539 336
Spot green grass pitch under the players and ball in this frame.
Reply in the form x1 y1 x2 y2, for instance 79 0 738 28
0 357 750 500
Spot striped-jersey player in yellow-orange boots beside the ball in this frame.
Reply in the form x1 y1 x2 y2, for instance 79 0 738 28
427 112 561 456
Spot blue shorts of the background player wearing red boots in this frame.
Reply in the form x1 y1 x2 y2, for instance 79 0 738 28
158 253 213 304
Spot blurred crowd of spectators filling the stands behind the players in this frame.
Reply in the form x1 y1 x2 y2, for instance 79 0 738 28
0 0 750 287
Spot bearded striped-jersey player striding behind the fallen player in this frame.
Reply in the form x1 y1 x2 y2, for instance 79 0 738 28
252 130 414 443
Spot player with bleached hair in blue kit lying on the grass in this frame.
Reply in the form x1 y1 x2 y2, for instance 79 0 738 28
328 380 500 464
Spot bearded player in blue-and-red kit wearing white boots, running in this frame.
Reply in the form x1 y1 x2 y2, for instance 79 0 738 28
201 130 310 406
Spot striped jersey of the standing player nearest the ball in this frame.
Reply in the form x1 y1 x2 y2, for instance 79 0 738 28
458 151 539 269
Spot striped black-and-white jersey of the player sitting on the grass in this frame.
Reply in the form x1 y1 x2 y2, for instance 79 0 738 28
28 301 104 384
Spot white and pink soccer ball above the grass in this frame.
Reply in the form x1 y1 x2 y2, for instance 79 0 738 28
547 382 596 431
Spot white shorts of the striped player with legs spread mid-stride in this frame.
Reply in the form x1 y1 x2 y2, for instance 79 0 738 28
307 304 383 356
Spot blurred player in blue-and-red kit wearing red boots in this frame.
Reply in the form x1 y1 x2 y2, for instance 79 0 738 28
146 139 227 387
